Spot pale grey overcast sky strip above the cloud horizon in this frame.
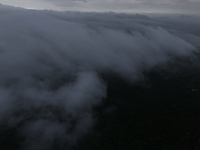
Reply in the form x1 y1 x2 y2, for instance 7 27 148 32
0 0 200 14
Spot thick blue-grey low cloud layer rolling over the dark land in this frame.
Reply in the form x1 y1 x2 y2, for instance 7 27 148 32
0 6 200 150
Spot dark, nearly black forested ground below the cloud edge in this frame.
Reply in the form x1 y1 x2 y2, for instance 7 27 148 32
0 51 200 150
